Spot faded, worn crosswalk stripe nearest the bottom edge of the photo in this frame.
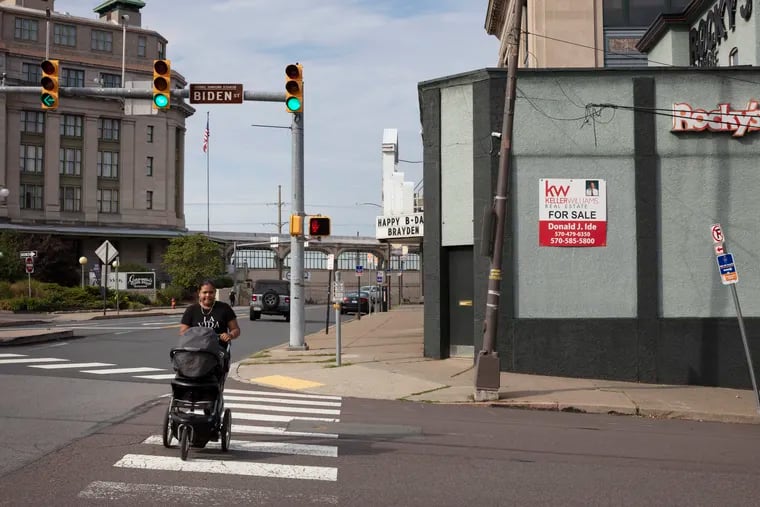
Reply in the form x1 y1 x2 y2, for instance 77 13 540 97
79 481 339 507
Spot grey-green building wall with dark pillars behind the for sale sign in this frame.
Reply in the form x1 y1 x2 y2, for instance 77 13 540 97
420 68 760 387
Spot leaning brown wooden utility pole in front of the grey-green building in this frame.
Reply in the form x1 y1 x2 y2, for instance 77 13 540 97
475 0 523 401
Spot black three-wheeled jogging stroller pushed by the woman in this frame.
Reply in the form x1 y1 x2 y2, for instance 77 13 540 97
163 327 232 460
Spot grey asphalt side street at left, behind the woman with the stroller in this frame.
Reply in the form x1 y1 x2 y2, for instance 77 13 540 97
0 307 336 476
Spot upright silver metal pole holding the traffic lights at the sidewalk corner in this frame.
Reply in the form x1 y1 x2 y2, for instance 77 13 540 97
288 113 309 350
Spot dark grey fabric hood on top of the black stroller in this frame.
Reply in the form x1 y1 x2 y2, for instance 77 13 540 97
169 326 225 378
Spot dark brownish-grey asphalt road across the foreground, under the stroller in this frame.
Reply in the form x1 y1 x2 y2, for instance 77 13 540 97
0 388 760 507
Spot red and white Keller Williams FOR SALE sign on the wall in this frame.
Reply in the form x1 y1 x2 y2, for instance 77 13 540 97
538 178 607 247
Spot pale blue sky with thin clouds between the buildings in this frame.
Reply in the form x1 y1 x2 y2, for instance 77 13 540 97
55 0 499 237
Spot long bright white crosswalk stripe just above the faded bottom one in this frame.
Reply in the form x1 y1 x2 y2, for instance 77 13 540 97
114 454 338 481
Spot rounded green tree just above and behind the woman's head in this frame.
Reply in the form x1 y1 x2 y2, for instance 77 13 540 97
162 234 224 289
